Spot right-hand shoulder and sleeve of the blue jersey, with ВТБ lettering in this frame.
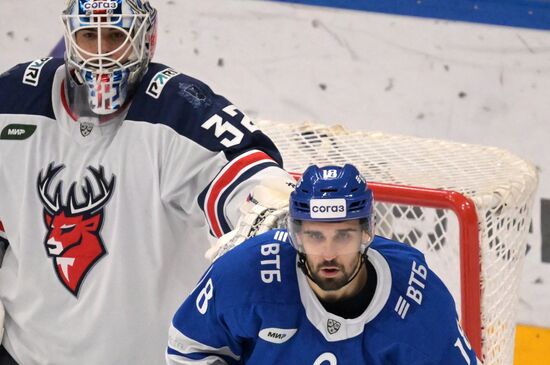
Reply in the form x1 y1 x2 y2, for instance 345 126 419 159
367 237 484 365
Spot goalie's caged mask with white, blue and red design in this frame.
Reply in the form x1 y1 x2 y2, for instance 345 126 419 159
62 0 157 119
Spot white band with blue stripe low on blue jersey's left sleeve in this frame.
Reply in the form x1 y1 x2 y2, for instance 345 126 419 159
167 324 241 365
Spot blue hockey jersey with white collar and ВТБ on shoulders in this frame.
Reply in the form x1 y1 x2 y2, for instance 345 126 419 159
166 230 484 365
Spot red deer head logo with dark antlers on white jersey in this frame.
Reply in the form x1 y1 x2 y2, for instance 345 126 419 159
37 163 115 296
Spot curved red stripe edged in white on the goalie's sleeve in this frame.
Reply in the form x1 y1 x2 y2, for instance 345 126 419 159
205 150 275 237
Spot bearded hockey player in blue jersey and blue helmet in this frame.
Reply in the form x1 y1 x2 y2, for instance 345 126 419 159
166 165 484 365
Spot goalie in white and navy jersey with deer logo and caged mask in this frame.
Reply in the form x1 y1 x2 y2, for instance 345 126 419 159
0 0 296 365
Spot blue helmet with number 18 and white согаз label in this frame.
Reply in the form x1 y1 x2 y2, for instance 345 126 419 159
288 164 374 252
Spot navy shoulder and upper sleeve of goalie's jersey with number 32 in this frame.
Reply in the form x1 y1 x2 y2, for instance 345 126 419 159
126 63 282 159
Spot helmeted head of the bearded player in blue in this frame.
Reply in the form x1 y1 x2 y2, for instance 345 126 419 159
288 164 374 290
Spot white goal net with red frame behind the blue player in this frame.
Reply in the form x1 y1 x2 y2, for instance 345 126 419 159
258 121 538 365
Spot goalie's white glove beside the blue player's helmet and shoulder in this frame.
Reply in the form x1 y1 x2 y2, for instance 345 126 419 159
205 178 296 262
